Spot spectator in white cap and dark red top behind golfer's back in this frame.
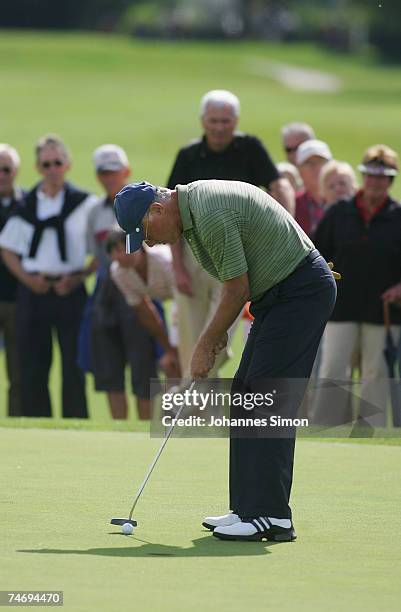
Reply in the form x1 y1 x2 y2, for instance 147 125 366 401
295 140 333 237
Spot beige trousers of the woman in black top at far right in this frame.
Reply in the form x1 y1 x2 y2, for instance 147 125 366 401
315 322 400 427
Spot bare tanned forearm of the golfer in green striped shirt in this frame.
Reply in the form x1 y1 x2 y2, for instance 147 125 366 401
200 274 249 346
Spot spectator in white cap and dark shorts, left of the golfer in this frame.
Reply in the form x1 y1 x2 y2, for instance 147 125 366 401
88 144 170 419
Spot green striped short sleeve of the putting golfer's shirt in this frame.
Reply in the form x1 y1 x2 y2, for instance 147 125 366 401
199 210 248 282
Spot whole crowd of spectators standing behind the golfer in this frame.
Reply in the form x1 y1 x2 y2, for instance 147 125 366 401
0 90 401 426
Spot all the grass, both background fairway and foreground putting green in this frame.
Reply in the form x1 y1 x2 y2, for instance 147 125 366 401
0 31 401 612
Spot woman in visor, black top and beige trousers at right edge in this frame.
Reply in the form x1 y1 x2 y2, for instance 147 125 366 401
315 145 401 426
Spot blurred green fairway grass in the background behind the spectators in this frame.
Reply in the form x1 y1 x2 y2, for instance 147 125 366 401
0 31 401 424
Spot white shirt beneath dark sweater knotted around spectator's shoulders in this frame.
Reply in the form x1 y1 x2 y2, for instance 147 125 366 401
0 189 97 275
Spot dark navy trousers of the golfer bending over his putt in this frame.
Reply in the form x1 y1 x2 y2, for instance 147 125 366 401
230 250 336 518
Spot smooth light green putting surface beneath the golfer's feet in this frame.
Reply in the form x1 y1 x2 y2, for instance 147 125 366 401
0 429 401 612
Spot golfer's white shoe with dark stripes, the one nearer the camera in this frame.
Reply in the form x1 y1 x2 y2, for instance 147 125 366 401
213 517 297 542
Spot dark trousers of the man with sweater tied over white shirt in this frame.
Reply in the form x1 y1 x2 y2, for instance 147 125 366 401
17 285 88 418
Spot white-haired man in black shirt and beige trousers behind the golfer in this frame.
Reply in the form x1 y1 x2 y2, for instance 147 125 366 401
167 90 295 377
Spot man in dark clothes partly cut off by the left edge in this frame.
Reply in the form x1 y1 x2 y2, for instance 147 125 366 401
0 143 24 416
